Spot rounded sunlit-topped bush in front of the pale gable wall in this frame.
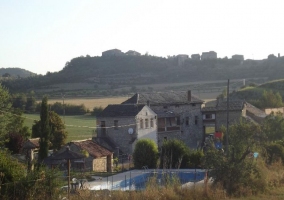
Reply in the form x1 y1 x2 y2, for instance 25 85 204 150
133 139 158 169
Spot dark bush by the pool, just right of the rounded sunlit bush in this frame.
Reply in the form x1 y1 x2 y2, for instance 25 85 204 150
160 139 189 169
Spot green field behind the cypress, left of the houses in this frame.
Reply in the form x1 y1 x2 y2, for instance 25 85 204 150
24 114 96 142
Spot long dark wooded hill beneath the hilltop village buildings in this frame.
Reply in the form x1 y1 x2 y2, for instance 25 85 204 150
2 55 284 96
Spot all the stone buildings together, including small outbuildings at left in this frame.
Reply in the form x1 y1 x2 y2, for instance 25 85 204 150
23 90 266 172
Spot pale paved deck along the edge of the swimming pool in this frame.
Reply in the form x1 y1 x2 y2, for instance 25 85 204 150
87 169 205 190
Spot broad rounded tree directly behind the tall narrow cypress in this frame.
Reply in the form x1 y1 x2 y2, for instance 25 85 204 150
32 111 68 150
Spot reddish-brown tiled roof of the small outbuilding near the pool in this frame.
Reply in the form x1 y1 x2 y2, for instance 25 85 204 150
71 140 112 158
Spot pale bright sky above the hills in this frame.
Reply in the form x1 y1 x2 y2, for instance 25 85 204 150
0 0 284 74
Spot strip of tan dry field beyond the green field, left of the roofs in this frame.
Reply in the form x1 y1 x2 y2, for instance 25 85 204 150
48 97 129 110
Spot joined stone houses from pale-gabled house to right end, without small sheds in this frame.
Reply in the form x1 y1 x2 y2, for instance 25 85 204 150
94 91 266 155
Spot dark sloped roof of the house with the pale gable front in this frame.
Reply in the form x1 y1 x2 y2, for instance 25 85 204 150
99 104 145 117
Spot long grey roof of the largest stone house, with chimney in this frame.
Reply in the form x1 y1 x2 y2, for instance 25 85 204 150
122 91 203 105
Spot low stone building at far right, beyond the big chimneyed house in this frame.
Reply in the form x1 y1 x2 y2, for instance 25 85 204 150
202 100 266 134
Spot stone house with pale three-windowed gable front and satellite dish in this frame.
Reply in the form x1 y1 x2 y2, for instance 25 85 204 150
94 104 157 155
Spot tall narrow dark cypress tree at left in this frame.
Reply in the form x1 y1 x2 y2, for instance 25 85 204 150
38 97 50 161
